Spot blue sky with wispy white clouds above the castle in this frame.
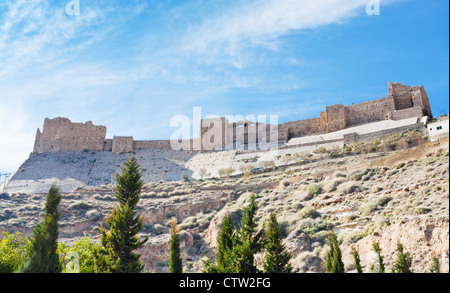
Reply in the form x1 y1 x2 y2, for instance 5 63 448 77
0 0 449 180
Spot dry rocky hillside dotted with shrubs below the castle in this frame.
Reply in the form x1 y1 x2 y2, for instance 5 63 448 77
0 138 449 272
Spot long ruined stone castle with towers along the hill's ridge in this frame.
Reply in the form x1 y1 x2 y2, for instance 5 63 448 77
32 83 432 155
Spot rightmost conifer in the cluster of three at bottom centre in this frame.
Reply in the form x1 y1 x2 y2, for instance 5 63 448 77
263 213 292 273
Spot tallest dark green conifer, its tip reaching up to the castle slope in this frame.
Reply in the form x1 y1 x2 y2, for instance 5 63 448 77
94 157 148 273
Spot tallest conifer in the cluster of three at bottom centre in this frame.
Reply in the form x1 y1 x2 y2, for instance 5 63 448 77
232 194 264 274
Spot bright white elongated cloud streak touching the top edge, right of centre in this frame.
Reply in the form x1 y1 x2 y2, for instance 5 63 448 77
182 0 368 56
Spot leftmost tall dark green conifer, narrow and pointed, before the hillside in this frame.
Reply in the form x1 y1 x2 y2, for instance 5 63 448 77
23 186 62 273
